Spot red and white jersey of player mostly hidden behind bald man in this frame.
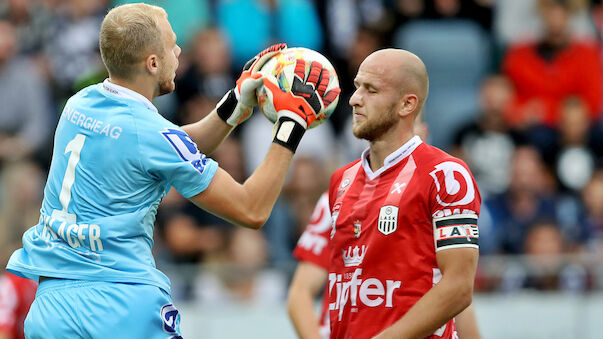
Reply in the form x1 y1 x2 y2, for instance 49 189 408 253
293 192 331 339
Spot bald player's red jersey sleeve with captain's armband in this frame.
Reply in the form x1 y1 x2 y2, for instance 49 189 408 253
429 158 481 252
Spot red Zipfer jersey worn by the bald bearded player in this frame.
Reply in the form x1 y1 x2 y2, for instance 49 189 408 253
327 136 481 339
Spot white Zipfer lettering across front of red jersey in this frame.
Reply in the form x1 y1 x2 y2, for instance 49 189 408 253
329 268 402 321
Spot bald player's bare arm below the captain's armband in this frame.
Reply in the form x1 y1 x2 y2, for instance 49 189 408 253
375 247 478 339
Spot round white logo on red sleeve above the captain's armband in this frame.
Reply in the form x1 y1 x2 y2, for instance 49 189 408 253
429 161 475 207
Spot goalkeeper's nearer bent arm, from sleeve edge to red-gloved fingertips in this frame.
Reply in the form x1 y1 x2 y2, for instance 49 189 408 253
191 61 340 229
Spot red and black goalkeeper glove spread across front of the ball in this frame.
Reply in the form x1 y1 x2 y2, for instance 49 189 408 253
264 59 341 129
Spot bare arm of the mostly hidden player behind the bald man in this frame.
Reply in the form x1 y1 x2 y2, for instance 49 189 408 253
287 261 327 339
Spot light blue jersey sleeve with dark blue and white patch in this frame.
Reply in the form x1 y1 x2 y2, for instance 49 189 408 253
138 121 218 198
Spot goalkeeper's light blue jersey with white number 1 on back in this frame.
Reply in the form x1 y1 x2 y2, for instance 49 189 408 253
7 80 218 293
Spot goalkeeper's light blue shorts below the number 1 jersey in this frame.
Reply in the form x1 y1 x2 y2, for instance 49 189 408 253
25 279 182 339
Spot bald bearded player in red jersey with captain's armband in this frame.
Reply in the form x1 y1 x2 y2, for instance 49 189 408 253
327 49 481 339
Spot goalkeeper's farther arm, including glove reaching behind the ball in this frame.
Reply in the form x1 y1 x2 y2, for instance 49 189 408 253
182 44 287 154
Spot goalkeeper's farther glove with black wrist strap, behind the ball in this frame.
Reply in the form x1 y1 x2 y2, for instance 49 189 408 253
216 44 287 127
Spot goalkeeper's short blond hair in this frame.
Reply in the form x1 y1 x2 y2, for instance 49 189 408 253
99 3 167 78
